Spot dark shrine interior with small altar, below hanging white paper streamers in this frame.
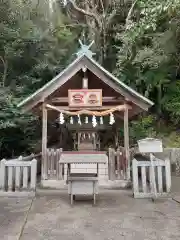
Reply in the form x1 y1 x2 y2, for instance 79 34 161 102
47 113 124 151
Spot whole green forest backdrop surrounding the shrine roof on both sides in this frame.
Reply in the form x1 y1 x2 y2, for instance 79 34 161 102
0 0 180 158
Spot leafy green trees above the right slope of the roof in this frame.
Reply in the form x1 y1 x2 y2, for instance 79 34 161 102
115 0 180 124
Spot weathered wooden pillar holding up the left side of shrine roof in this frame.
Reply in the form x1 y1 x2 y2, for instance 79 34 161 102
41 103 47 180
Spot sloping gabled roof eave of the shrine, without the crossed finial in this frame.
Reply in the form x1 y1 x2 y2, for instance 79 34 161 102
18 55 153 116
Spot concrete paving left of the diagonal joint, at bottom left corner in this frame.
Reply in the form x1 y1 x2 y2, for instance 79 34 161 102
0 197 32 240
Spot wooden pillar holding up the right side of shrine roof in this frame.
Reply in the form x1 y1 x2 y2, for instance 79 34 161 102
124 108 130 180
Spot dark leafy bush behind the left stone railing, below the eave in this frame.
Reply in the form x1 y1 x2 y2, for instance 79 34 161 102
0 88 40 158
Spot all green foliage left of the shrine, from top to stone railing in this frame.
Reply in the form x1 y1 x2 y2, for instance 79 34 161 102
0 0 78 158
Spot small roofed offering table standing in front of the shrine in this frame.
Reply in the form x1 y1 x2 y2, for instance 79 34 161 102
59 152 108 204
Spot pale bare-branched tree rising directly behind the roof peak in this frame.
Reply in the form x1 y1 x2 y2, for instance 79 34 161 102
61 0 122 66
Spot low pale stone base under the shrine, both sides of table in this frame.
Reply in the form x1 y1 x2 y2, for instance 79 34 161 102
41 179 131 189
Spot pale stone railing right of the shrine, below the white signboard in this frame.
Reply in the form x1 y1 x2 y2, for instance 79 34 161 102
132 158 171 198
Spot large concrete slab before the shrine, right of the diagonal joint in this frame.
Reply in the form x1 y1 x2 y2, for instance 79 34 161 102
21 190 180 240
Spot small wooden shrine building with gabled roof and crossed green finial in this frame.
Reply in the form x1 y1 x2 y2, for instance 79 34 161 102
18 40 153 186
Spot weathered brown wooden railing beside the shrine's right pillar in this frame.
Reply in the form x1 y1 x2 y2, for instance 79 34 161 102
109 147 127 180
